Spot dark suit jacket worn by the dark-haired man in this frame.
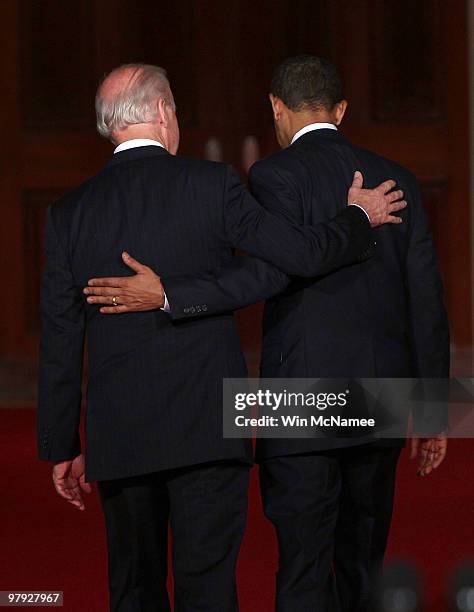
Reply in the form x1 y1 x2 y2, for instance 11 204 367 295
164 129 449 456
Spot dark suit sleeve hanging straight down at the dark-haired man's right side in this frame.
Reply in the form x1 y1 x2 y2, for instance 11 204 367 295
406 181 450 436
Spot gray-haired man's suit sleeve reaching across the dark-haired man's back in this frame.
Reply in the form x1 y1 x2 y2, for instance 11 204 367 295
220 164 373 277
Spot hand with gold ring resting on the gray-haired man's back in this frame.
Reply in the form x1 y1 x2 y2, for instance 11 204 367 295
84 252 165 314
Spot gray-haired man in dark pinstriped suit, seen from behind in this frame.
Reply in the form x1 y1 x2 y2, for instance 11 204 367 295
37 64 405 612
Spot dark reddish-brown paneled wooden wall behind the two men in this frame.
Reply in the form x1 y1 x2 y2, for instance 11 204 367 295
0 0 472 359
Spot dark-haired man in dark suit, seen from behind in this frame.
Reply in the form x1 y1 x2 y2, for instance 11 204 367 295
83 56 449 612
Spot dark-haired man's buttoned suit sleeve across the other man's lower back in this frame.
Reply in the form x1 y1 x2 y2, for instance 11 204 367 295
161 256 290 320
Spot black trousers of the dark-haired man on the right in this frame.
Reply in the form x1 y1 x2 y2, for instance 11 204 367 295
260 445 401 612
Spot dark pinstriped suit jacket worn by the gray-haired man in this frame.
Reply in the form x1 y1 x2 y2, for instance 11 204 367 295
37 141 372 481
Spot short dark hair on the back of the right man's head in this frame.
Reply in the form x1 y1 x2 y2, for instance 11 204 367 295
270 55 344 112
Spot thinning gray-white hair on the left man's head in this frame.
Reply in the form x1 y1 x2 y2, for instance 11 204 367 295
95 64 174 139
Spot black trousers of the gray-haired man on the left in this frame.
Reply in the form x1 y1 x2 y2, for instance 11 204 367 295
98 461 249 612
